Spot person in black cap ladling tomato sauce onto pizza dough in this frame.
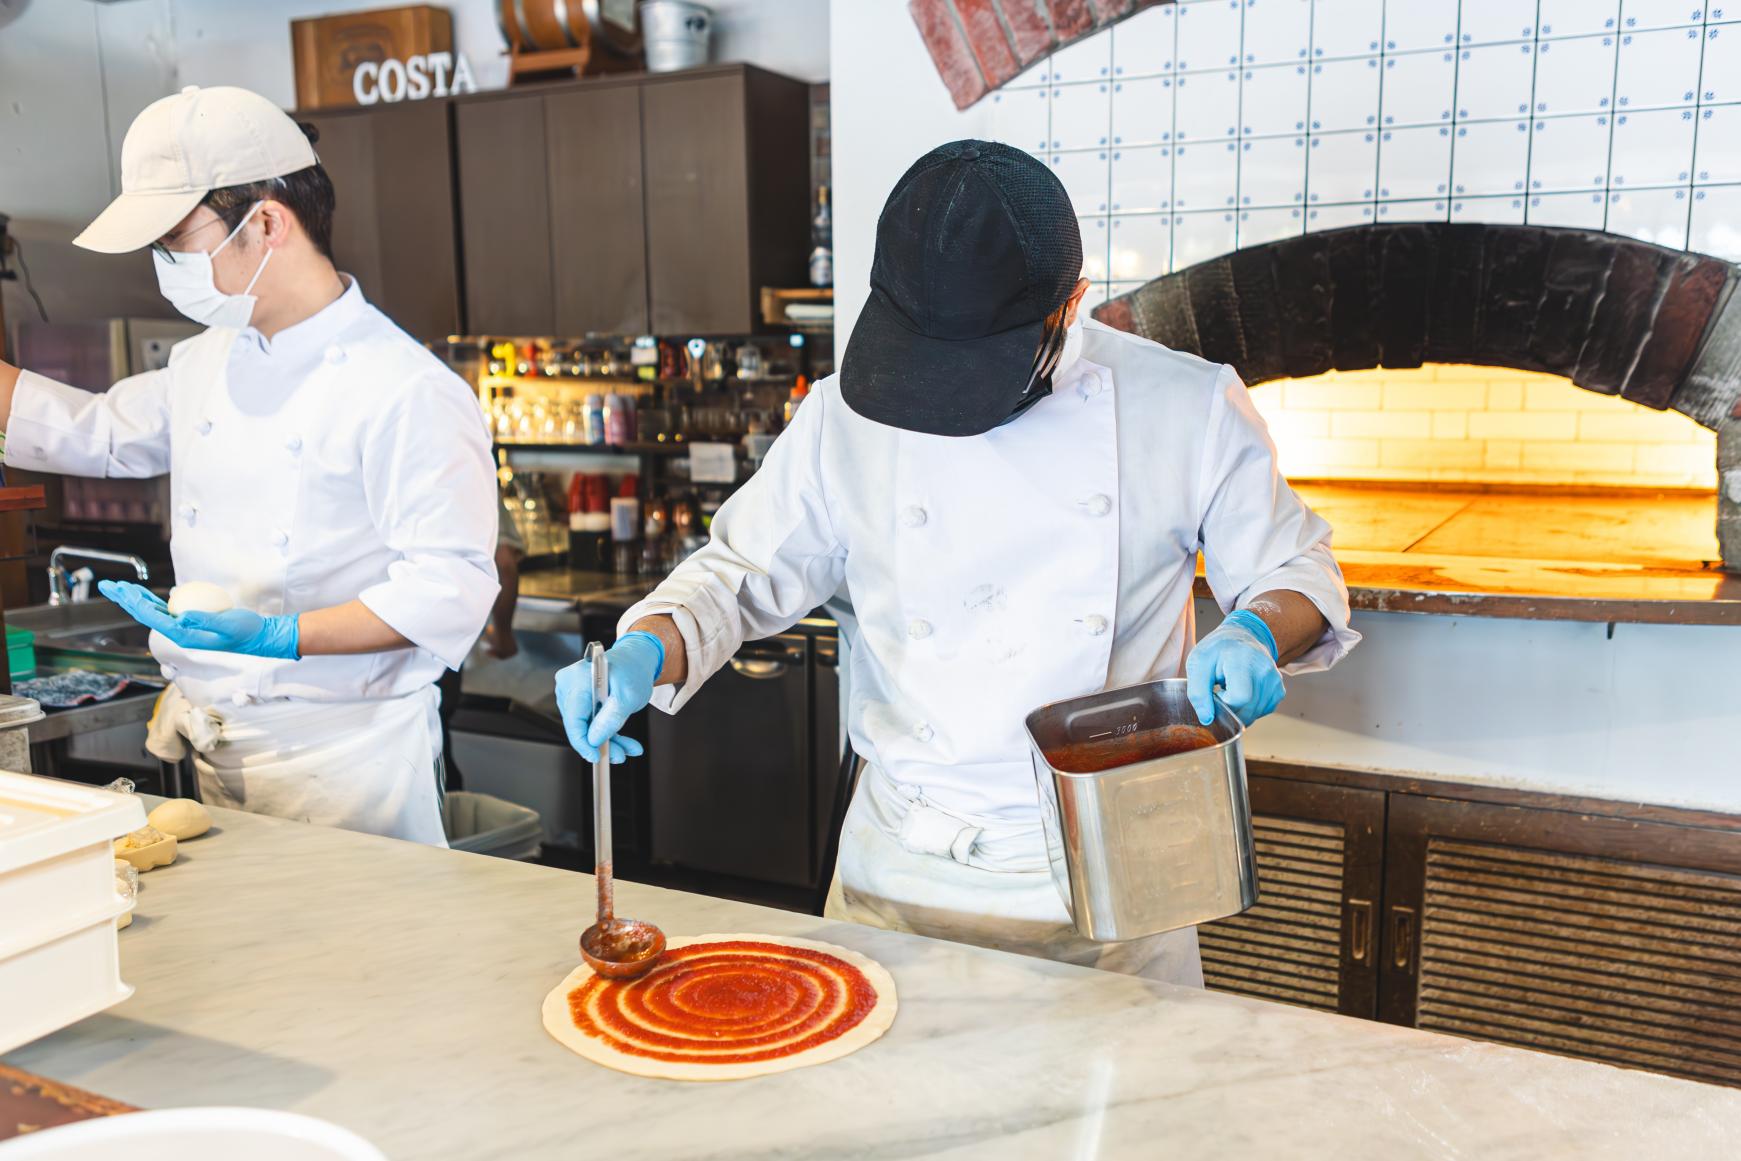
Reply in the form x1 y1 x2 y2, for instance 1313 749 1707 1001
557 141 1360 983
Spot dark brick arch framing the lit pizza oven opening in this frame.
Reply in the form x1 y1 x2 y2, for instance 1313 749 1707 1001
1093 223 1741 571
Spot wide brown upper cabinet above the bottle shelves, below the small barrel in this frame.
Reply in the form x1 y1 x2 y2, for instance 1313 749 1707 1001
454 64 810 336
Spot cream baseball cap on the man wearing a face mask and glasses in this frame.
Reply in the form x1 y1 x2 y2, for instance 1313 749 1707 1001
73 85 319 254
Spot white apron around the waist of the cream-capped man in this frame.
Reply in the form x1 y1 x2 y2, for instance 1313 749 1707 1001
146 686 447 846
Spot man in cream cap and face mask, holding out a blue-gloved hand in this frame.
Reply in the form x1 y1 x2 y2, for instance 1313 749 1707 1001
0 87 496 844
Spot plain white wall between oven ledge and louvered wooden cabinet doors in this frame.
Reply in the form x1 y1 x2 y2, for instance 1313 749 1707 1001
1196 601 1741 811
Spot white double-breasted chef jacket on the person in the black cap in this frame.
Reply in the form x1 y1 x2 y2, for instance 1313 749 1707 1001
622 322 1360 829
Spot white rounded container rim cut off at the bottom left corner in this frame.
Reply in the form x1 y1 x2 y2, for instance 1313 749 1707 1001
5 1109 387 1161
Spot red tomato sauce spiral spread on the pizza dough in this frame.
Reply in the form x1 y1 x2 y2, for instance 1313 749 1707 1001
568 940 877 1065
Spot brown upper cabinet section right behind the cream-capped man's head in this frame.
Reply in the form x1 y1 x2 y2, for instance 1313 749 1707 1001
296 101 465 341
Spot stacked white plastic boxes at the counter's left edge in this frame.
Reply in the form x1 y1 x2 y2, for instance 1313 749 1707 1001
0 771 145 1053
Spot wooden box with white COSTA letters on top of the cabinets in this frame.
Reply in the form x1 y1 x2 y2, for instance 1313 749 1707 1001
291 3 477 110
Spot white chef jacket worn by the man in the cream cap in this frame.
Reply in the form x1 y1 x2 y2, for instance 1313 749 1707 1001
5 275 496 705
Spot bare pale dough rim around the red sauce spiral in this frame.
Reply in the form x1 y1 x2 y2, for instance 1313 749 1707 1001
543 935 897 1081
